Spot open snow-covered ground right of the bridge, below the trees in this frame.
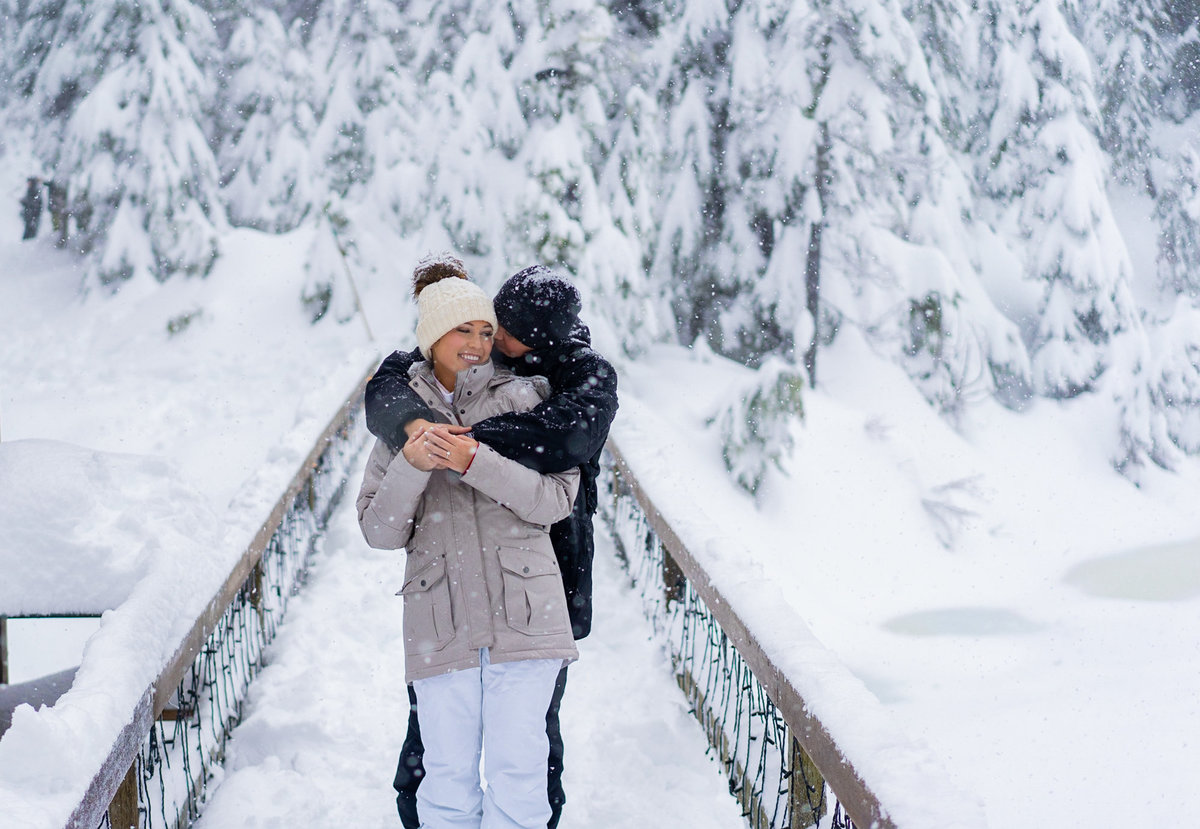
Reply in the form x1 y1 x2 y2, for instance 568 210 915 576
614 331 1200 829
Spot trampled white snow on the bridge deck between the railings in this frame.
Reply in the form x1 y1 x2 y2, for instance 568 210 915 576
196 453 745 829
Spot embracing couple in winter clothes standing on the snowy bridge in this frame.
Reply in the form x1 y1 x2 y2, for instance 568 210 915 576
358 256 617 829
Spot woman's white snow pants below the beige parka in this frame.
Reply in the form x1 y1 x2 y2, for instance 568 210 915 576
413 648 563 829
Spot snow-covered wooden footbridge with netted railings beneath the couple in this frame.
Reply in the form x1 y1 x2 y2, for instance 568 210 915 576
0 371 983 829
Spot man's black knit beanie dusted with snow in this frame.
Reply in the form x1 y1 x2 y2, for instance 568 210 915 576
496 265 582 348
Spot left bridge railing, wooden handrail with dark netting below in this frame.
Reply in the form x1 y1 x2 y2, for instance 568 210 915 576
67 369 367 829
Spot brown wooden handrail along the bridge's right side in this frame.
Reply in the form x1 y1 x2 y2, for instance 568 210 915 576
607 439 896 829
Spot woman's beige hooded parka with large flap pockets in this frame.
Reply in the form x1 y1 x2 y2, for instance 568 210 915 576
356 361 578 683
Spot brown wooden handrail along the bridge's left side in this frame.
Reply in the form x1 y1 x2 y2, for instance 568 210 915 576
66 367 374 829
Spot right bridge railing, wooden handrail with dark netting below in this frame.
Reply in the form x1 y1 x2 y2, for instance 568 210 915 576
600 441 893 829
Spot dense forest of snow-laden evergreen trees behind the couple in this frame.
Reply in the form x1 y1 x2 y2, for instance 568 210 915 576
0 0 1200 489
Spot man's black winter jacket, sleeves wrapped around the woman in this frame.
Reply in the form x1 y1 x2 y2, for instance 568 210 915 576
366 324 617 639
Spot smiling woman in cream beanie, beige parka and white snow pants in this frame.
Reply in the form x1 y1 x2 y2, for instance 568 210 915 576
358 259 578 829
